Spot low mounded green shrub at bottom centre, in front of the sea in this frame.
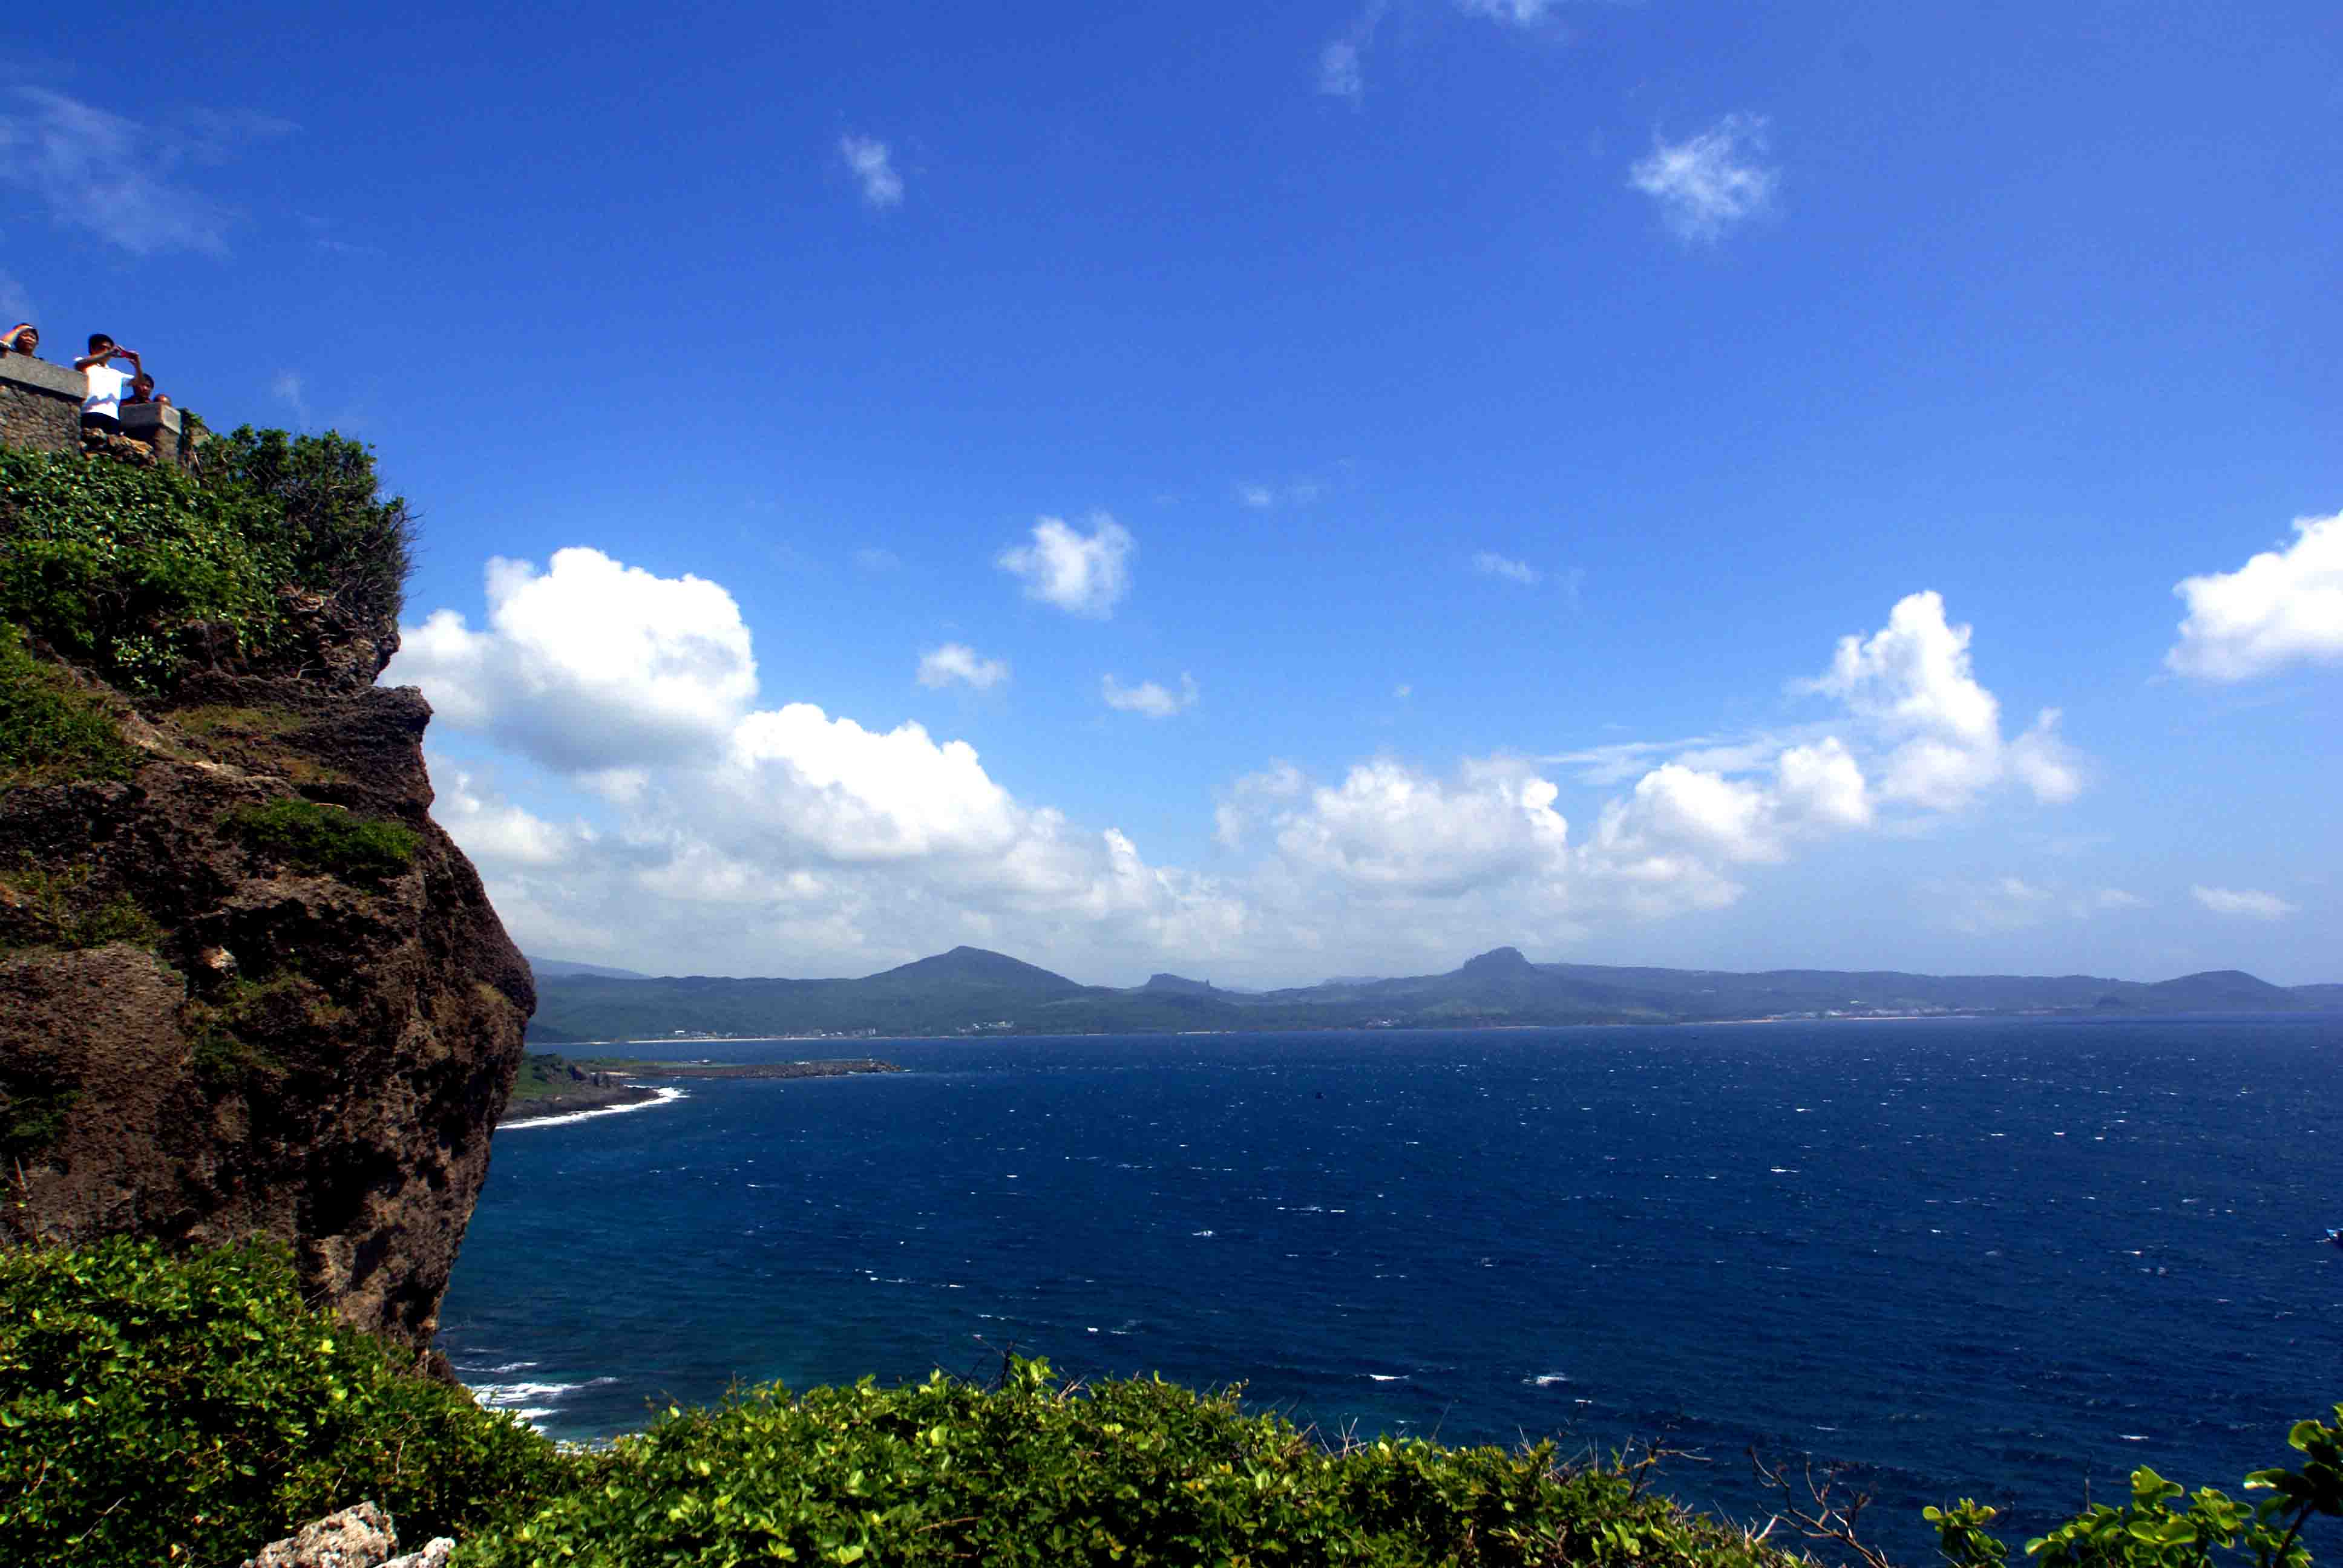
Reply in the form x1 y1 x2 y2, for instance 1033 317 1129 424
462 1362 1781 1568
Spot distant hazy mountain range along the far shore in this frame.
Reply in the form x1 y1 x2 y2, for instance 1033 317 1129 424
529 947 2343 1043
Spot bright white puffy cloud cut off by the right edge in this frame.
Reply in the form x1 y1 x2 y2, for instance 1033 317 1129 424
2165 511 2343 680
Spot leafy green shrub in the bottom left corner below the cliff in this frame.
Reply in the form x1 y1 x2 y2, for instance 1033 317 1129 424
0 1240 581 1563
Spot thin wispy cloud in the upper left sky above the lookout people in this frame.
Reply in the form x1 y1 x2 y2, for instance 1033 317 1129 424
0 87 295 255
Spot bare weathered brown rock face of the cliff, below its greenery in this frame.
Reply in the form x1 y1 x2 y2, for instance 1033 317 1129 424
0 656 537 1348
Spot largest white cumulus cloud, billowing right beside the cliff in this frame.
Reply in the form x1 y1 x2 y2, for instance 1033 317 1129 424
387 549 1249 975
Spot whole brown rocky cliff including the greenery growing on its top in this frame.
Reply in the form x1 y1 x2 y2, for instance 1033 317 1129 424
0 431 537 1348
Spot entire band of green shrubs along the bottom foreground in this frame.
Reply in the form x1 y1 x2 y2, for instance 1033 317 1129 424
0 1240 2343 1568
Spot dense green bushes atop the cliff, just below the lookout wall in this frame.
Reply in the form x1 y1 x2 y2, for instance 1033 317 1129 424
0 426 415 694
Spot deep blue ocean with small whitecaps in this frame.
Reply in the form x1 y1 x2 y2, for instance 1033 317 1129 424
441 1018 2343 1557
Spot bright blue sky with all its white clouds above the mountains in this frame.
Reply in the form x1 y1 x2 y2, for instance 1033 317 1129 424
0 0 2343 984
